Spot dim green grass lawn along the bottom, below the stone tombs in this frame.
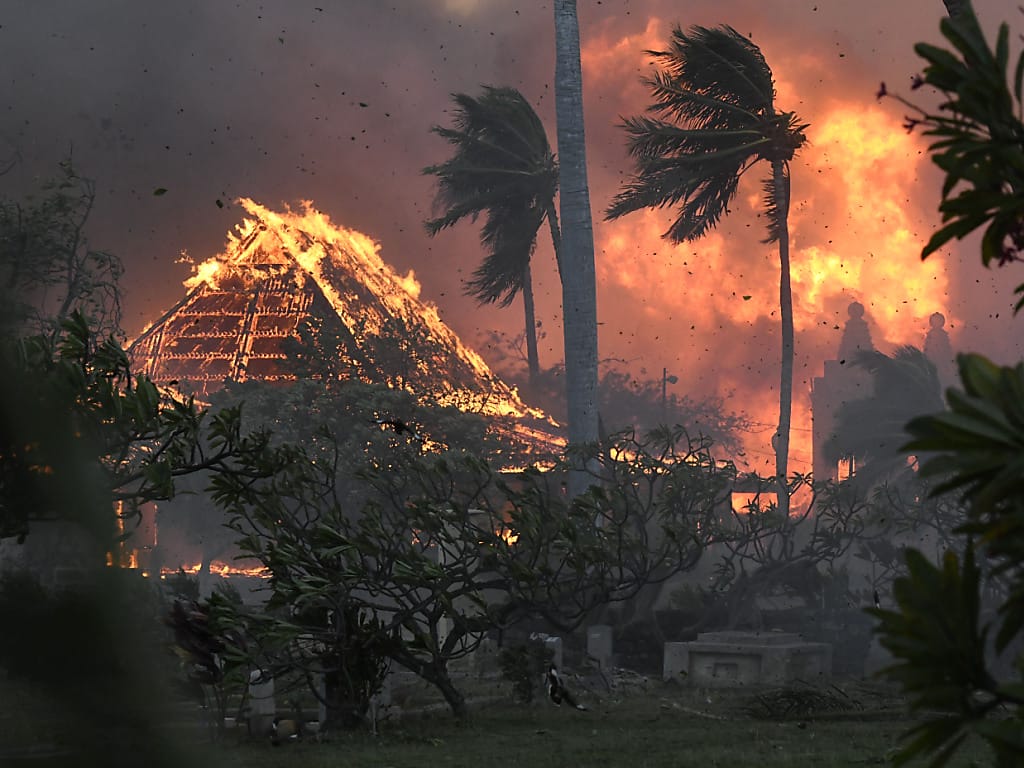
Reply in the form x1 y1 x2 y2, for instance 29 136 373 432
203 689 988 768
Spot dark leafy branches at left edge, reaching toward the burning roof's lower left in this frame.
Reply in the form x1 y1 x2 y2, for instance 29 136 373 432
0 311 258 551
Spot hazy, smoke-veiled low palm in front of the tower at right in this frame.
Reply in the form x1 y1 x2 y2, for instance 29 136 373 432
823 346 945 487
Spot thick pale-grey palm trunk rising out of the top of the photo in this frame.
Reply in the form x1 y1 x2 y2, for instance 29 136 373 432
554 0 598 497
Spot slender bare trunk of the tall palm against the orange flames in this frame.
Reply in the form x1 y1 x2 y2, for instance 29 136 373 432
772 160 795 515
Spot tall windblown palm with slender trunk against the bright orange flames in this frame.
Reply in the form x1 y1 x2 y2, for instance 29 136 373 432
607 27 807 511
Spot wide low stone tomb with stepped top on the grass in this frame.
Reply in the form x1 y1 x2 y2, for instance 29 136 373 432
663 632 831 688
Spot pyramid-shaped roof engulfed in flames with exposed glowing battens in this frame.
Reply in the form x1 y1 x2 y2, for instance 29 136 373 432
129 199 561 456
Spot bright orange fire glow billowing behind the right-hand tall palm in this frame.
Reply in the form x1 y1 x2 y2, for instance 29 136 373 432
583 18 961 471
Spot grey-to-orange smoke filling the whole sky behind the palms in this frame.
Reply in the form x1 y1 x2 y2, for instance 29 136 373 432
0 0 1022 473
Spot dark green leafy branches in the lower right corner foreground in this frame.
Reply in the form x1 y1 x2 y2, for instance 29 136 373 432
871 354 1024 766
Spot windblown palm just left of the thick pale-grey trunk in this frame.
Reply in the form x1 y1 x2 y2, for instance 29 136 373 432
423 86 560 382
